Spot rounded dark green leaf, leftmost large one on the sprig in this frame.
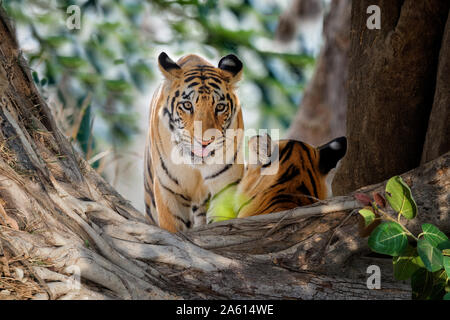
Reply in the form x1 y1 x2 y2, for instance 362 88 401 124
368 221 408 257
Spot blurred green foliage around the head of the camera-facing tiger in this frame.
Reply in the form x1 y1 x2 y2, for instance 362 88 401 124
2 0 314 165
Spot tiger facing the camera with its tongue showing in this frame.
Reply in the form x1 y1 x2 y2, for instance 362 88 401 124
144 52 244 232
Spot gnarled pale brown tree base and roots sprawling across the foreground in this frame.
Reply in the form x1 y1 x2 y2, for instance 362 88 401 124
0 5 450 299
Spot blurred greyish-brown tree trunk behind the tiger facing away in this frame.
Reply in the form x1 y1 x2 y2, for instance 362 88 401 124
287 0 351 146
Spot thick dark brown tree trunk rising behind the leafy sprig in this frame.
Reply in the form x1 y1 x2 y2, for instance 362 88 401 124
333 0 450 194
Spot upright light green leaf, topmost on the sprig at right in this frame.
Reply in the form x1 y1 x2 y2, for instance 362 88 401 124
386 176 417 219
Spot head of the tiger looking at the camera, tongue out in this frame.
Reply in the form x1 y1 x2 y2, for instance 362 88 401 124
158 53 242 166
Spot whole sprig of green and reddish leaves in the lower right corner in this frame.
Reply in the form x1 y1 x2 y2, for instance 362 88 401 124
355 176 450 300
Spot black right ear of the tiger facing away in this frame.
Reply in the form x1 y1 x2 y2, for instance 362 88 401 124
318 137 347 174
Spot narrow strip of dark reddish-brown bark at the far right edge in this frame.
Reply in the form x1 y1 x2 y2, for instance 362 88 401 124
422 11 450 163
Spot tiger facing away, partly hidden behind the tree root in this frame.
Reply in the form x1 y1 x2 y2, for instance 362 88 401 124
207 134 347 223
